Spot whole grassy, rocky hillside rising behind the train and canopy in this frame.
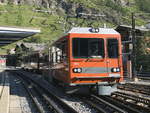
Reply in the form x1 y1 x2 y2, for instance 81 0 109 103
0 0 150 52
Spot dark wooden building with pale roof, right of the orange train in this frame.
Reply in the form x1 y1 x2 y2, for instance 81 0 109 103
116 25 149 78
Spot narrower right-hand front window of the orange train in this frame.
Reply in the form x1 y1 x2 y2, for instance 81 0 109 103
107 39 119 58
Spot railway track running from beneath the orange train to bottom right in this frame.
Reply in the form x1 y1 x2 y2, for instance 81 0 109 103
84 95 149 113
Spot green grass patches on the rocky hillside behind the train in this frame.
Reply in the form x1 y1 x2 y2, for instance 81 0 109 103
0 0 148 54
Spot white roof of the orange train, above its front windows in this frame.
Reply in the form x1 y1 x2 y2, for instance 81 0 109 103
68 27 119 35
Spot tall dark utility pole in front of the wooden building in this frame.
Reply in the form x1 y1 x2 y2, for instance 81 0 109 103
131 13 137 78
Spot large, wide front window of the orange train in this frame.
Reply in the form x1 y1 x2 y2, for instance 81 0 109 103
73 38 104 58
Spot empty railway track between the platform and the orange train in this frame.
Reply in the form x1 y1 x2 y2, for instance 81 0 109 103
12 72 77 113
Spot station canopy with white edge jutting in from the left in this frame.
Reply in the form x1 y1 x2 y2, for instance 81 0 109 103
0 27 40 46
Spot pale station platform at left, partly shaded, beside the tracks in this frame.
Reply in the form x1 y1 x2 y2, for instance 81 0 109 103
0 68 36 113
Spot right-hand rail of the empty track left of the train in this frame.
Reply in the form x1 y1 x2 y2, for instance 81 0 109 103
13 71 77 113
